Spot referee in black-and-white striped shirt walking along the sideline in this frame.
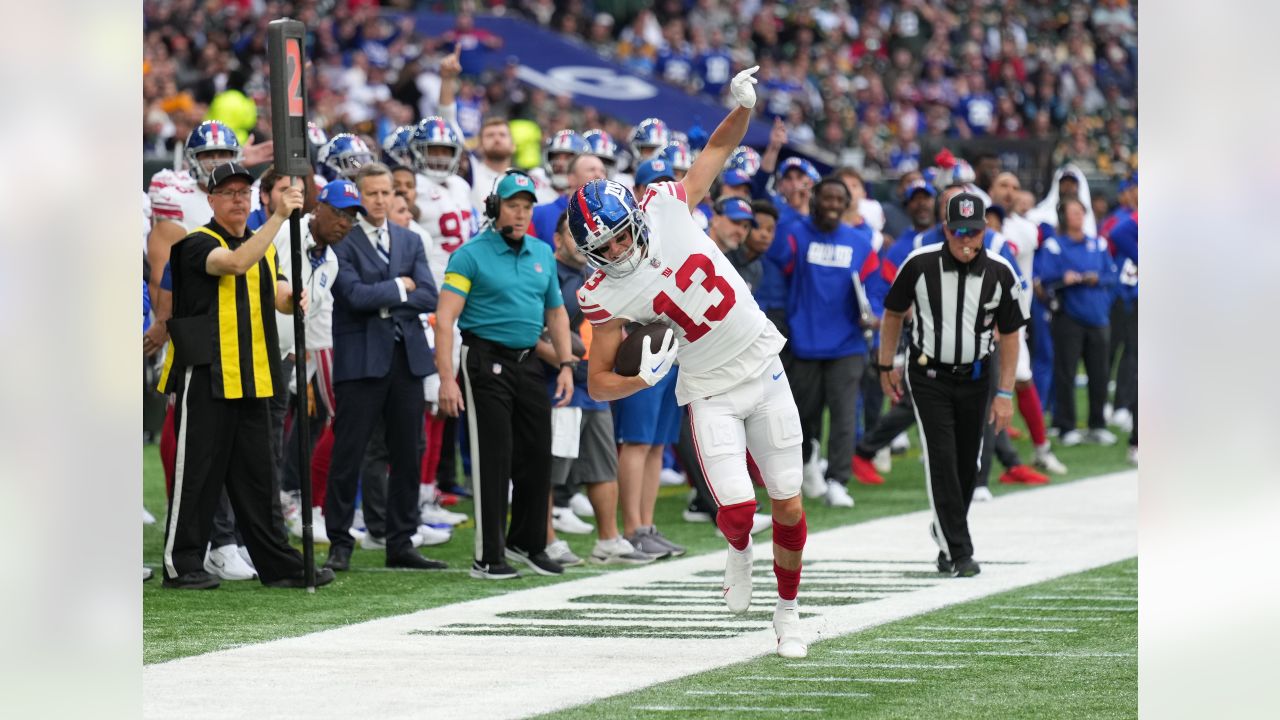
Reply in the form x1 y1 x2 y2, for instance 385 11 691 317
878 192 1027 578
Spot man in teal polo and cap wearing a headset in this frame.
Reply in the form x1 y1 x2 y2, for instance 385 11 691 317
435 169 576 580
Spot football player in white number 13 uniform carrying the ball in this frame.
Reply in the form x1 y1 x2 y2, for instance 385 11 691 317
570 67 808 657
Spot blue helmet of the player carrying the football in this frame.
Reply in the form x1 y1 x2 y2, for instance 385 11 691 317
568 179 649 278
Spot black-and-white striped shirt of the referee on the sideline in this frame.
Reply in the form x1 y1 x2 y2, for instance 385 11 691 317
884 242 1027 365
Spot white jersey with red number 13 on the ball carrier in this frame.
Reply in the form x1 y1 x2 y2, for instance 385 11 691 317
577 182 786 405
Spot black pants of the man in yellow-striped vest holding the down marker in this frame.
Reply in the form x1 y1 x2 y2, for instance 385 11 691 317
164 365 302 583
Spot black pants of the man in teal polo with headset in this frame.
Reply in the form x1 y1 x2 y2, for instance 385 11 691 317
461 340 552 565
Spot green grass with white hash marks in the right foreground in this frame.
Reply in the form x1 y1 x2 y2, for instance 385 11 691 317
540 559 1138 720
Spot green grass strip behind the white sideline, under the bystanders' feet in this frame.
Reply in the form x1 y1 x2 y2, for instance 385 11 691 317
142 399 1128 662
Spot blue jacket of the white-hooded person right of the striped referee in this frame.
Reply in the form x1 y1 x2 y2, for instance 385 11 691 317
1032 234 1119 328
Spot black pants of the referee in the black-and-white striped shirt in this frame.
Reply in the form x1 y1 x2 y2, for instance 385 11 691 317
906 363 989 561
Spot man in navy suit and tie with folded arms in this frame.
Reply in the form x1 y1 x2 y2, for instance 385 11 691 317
324 163 445 570
